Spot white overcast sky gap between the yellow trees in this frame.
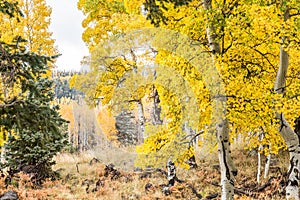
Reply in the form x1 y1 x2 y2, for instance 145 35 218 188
46 0 88 71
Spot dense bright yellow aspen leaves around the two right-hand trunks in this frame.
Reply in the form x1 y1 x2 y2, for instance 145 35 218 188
157 0 300 153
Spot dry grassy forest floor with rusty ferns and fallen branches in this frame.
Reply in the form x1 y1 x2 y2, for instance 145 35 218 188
0 146 288 200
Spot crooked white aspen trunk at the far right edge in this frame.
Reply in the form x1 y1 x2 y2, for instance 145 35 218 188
274 8 300 200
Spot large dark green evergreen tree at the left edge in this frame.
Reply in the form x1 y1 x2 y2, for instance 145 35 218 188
0 1 67 181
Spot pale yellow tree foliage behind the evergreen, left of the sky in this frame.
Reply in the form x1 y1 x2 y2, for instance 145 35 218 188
0 0 57 56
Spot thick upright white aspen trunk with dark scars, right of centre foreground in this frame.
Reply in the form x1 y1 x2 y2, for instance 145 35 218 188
202 0 237 200
